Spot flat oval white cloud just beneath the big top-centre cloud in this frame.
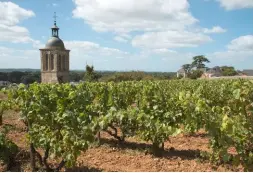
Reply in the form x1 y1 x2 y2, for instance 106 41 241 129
132 31 212 49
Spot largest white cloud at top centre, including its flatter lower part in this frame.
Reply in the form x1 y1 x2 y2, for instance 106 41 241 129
73 0 217 49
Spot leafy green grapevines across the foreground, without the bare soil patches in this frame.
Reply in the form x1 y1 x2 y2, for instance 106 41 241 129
0 79 253 171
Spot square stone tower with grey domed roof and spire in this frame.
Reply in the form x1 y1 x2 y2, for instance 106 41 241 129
40 15 70 83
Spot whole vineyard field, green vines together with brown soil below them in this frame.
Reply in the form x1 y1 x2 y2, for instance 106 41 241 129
0 79 253 171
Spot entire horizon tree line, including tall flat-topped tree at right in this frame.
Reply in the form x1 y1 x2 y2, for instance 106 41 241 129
0 55 238 84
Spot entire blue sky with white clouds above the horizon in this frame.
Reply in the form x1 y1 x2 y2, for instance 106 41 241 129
0 0 253 72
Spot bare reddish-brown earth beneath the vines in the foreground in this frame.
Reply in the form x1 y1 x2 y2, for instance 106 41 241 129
0 111 243 172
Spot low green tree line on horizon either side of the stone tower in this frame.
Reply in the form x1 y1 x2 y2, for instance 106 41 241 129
0 68 176 84
